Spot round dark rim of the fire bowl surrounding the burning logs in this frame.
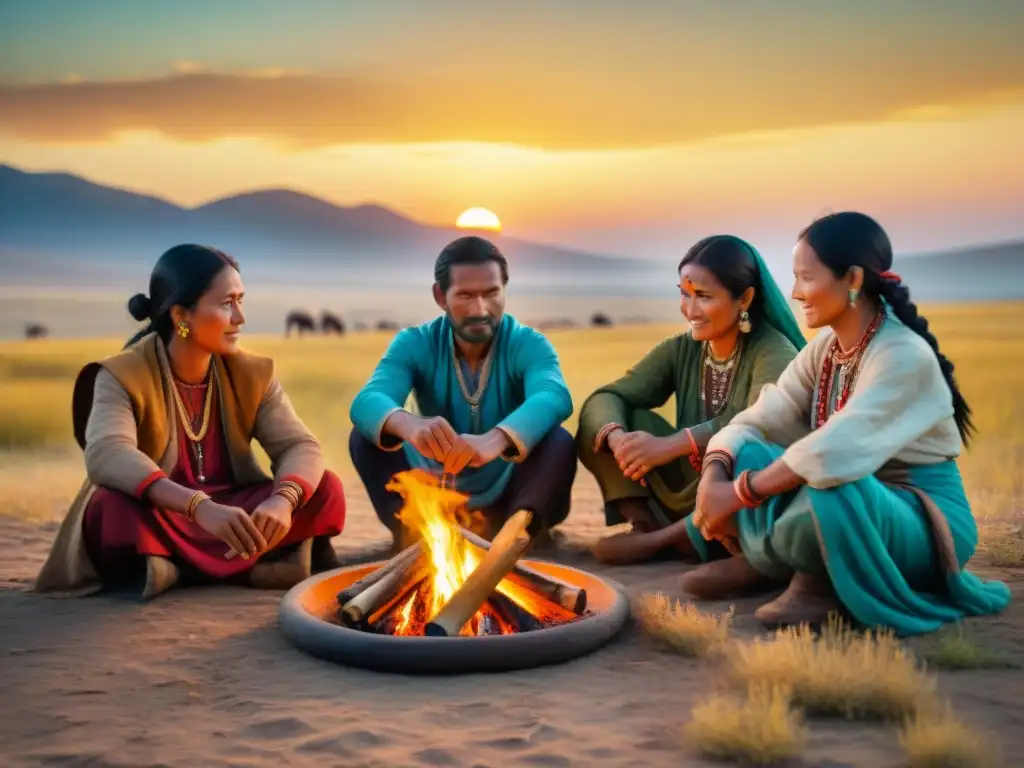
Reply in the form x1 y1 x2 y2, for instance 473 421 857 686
278 560 630 675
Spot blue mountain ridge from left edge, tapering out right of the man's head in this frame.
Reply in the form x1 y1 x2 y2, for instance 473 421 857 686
0 165 636 283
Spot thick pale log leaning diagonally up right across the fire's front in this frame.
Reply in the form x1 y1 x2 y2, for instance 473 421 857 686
425 510 531 637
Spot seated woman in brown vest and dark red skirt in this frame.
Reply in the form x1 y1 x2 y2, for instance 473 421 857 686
36 245 345 599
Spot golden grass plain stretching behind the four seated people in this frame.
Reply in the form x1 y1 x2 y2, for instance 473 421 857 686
0 303 1024 565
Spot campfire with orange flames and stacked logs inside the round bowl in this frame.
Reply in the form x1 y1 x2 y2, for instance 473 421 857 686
338 470 588 637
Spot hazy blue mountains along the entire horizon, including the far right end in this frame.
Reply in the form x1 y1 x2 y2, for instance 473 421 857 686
0 165 1024 301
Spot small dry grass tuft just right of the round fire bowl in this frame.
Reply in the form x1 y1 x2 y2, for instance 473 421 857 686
634 593 733 657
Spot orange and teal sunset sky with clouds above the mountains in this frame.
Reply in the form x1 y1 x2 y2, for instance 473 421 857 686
0 0 1024 255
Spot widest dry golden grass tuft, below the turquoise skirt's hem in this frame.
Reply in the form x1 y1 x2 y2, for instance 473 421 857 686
730 617 935 720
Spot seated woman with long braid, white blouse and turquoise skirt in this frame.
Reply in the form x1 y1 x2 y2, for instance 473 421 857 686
683 212 1010 635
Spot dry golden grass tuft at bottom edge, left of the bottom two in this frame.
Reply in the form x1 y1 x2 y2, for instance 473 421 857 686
684 685 807 765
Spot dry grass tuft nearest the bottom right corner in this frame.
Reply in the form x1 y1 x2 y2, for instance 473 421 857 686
899 710 1000 768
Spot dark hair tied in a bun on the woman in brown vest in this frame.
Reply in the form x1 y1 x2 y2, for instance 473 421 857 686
125 243 239 347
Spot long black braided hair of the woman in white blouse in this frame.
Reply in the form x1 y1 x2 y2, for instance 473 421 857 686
800 211 974 444
